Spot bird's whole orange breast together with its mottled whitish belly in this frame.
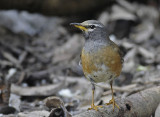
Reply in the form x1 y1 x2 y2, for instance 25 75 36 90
81 46 122 82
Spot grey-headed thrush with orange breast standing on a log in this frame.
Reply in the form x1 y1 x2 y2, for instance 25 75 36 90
70 20 123 111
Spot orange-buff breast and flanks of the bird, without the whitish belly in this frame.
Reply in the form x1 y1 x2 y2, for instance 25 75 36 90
81 43 122 77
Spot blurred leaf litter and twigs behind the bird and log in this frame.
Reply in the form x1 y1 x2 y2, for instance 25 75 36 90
0 0 160 117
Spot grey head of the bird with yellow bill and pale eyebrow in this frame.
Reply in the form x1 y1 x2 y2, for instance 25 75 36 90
71 20 107 39
